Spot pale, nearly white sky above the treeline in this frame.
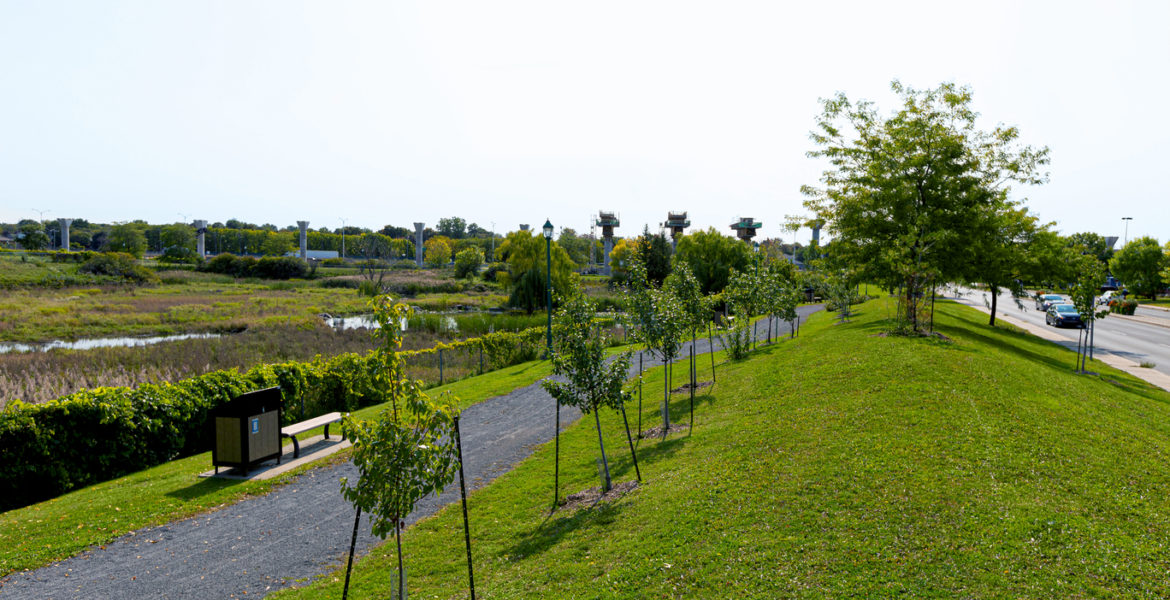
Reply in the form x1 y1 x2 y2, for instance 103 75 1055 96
0 0 1170 242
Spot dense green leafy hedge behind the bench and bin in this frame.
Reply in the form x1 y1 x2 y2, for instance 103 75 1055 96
0 329 542 511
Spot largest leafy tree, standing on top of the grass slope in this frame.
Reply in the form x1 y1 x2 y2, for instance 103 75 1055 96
803 81 1048 332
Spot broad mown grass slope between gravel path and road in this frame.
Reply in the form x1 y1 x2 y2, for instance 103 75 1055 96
275 301 1170 599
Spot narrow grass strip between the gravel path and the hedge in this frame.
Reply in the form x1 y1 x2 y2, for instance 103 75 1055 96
0 353 551 577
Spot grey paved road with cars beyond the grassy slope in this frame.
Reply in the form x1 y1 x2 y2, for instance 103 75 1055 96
951 288 1170 374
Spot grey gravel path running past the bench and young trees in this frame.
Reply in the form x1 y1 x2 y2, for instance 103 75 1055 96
0 306 820 600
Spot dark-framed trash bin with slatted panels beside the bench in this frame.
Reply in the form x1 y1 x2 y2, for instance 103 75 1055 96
211 387 282 473
